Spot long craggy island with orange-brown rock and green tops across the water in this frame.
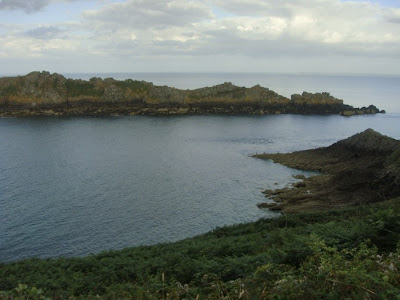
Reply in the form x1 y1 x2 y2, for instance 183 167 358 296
0 71 385 117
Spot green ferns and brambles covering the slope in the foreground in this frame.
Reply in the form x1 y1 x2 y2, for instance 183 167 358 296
0 198 400 299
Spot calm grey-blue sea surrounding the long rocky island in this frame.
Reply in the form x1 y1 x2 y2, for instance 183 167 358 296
0 73 400 262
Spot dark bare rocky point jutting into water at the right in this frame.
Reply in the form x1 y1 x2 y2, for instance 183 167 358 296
255 129 400 212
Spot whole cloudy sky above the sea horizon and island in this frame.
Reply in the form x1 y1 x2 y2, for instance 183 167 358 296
0 0 400 74
